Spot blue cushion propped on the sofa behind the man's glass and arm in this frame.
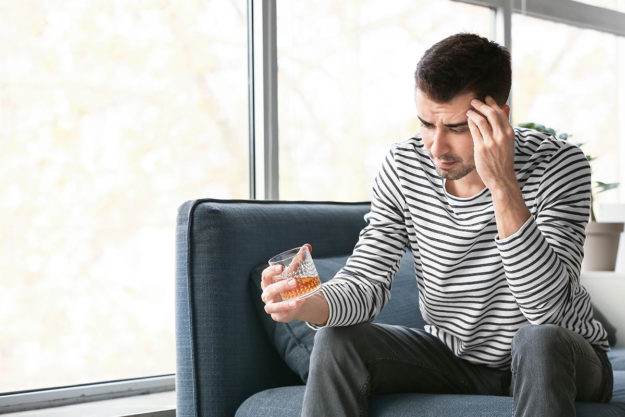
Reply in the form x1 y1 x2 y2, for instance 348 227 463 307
250 248 425 382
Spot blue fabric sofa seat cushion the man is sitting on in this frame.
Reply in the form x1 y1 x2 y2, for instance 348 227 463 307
236 382 625 417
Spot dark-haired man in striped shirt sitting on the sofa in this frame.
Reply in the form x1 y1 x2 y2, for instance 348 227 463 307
262 34 612 417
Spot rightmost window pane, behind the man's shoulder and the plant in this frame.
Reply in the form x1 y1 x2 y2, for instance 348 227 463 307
512 15 625 203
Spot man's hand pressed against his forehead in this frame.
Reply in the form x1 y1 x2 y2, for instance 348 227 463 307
467 97 516 192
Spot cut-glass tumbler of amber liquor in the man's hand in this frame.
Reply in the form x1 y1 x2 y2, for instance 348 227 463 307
269 245 321 300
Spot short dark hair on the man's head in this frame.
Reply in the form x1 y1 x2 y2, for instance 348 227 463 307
415 33 512 105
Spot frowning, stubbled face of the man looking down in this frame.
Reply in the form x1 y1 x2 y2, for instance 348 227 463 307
416 89 476 180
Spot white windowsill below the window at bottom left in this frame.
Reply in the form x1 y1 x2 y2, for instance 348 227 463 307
4 391 176 417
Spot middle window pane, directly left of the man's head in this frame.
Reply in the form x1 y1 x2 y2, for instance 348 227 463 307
277 0 494 201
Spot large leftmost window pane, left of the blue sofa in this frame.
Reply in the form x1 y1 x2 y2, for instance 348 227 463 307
0 0 248 392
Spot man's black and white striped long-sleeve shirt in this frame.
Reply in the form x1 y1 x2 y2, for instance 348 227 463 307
322 129 609 368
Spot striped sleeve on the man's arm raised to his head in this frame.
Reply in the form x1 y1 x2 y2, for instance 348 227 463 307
497 145 590 324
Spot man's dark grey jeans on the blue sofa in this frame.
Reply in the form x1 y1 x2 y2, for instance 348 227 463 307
302 323 612 417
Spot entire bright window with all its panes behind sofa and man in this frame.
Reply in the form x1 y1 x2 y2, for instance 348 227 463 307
0 0 625 410
